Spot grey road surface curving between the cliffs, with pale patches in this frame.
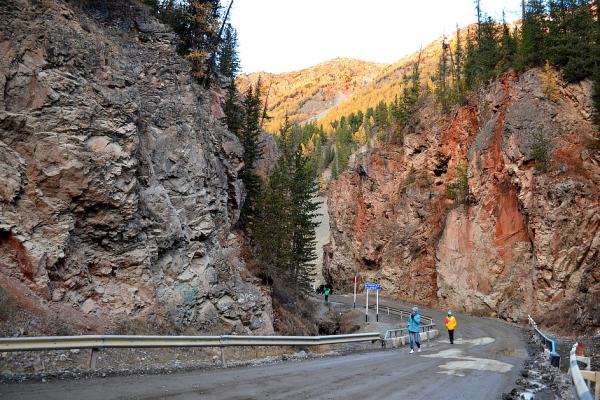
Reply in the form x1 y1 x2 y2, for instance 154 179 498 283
0 296 527 400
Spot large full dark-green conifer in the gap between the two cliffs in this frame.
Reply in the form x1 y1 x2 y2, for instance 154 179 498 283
253 118 318 294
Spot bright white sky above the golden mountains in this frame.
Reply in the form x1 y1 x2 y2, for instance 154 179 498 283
230 0 521 73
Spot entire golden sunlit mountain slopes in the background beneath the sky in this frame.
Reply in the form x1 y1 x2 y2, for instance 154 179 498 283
237 26 474 136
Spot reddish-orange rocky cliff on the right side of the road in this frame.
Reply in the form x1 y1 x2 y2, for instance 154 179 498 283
324 70 600 329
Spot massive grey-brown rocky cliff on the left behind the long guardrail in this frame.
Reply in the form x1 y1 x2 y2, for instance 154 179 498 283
0 0 272 334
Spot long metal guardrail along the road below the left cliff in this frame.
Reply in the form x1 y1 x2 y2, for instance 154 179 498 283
0 332 381 352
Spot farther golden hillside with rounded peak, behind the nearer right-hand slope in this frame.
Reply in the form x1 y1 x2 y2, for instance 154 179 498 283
237 58 384 132
